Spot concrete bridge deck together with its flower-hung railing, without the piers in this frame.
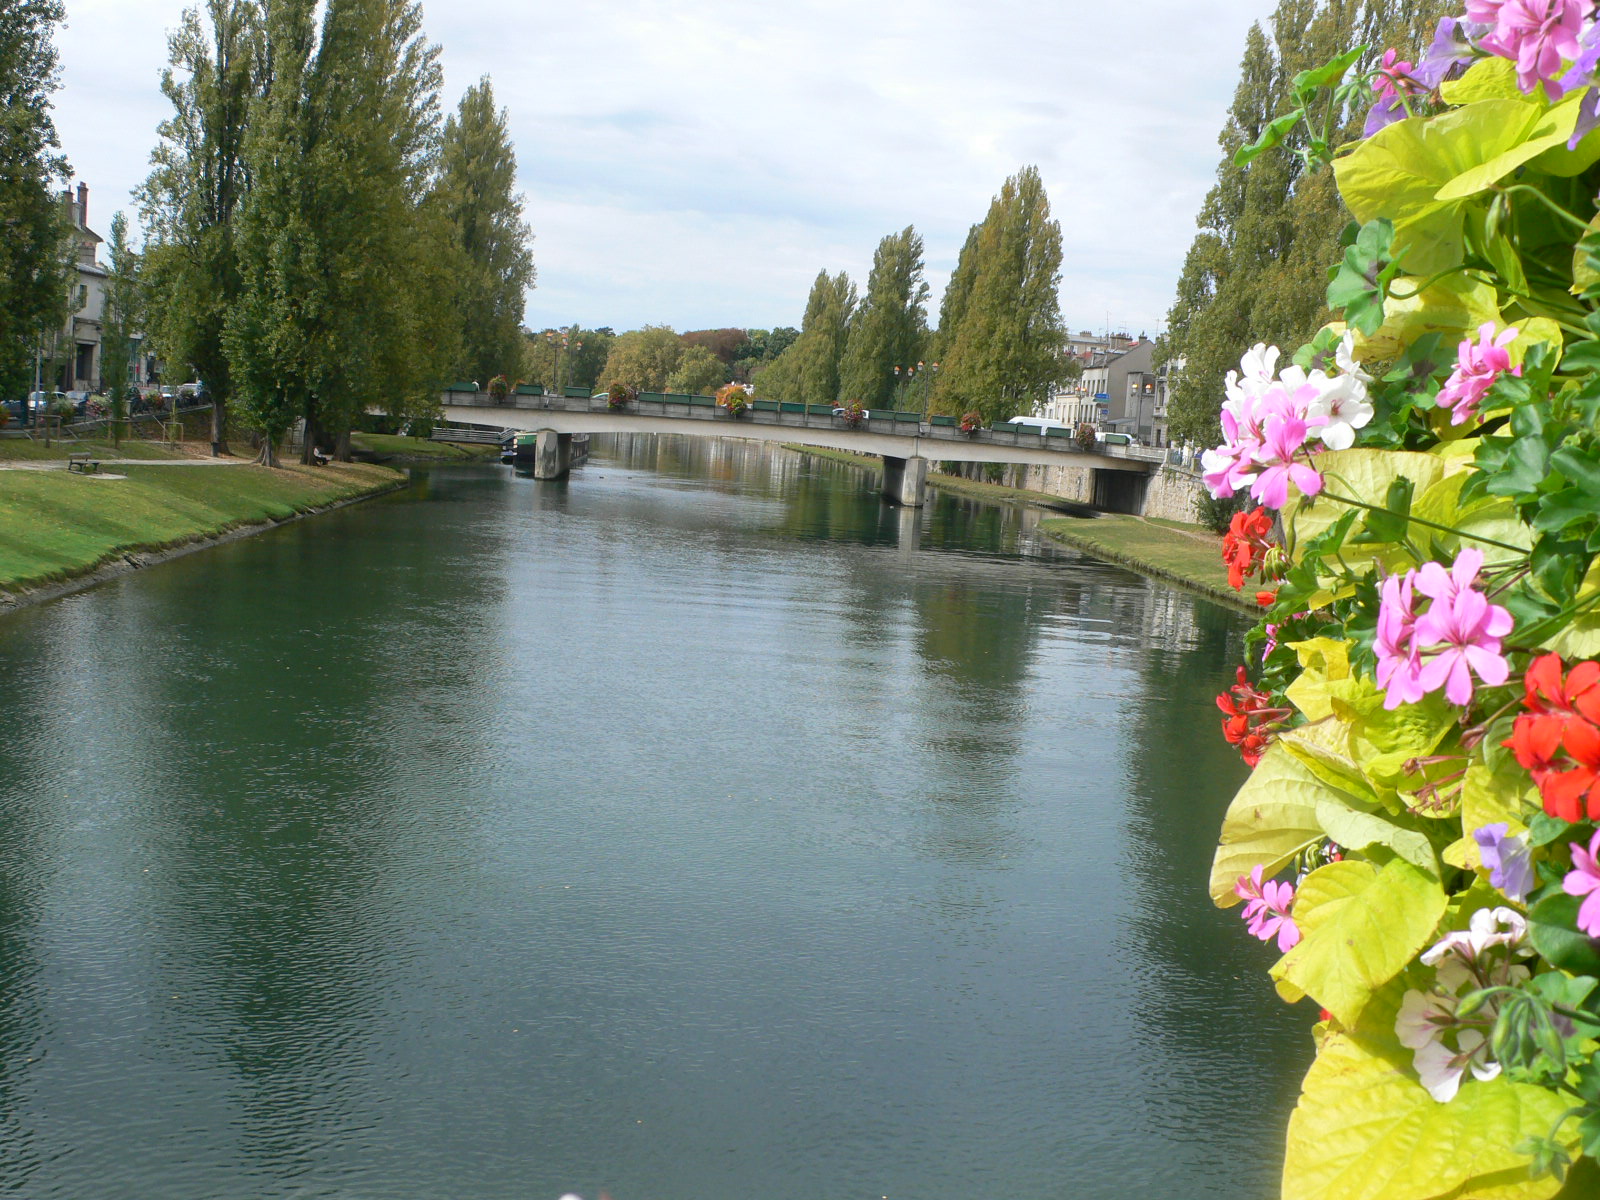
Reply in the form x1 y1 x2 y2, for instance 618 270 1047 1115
440 392 1165 472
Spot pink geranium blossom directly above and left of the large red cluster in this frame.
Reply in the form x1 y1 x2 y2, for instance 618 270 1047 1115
1373 550 1512 709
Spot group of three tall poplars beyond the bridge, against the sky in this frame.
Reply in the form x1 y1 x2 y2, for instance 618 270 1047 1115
755 166 1067 421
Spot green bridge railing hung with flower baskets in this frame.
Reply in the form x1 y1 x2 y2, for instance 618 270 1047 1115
443 389 1166 462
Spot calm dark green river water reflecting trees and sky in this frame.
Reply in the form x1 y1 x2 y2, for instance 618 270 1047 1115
0 440 1314 1200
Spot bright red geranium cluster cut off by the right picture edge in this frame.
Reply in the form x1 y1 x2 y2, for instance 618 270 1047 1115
1504 654 1600 821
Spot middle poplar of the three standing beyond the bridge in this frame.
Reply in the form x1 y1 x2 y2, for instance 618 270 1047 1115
838 226 928 408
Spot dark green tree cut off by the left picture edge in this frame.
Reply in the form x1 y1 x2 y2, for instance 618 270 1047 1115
0 0 74 404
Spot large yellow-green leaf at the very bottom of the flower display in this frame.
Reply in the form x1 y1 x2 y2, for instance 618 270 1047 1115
1282 982 1578 1200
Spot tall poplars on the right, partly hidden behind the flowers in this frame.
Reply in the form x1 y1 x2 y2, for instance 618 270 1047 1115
1160 0 1458 445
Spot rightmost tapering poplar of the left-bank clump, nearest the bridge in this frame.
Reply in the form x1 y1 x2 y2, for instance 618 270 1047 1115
438 75 534 379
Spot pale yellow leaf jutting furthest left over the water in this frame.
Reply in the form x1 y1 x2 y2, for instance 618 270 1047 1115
1211 744 1330 909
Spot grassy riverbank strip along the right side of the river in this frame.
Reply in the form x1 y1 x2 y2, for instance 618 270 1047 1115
789 445 1259 613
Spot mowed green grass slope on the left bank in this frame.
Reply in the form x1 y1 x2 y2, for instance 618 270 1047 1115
0 462 403 592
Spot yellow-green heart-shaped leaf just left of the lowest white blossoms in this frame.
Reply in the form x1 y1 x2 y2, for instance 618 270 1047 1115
1272 858 1448 1026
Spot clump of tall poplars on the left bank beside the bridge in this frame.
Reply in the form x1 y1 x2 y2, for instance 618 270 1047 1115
130 0 533 461
